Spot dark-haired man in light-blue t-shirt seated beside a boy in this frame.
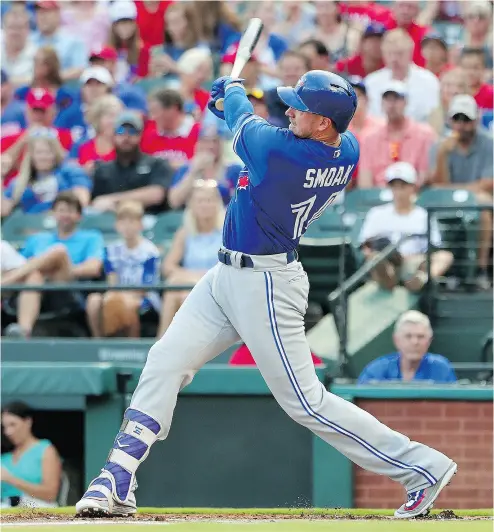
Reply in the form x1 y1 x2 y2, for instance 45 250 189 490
22 190 104 282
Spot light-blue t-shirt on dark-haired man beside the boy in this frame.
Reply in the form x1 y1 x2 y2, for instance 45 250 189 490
22 229 105 265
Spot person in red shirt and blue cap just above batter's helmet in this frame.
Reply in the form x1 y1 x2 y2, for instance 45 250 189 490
335 24 386 78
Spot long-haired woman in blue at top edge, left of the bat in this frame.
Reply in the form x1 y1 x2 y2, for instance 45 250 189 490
145 2 208 81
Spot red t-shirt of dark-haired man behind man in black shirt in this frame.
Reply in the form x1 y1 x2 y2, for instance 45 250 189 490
141 116 201 168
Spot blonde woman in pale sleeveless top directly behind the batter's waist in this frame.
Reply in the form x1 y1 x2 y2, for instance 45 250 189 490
157 180 225 338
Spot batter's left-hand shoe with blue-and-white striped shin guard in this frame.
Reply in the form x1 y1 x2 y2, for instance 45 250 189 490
76 409 161 517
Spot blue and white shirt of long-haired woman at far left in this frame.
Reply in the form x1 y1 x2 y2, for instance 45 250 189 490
5 164 93 213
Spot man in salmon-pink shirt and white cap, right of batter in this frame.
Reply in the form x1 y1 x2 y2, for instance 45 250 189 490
359 81 435 188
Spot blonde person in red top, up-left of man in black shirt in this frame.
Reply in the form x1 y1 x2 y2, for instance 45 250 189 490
69 94 123 175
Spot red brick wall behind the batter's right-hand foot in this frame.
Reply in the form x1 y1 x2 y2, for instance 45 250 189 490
354 400 493 508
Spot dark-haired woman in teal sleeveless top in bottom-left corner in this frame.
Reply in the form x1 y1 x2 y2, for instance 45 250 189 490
1 402 62 508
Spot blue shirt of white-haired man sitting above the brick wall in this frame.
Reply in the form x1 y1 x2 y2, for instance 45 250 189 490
357 353 456 384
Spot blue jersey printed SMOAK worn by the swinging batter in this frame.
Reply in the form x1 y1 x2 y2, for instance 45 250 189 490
223 113 359 255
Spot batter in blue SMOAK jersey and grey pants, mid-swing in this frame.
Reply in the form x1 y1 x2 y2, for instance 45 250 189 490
76 70 457 518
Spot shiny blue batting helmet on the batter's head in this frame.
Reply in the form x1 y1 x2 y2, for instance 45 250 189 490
277 70 357 133
